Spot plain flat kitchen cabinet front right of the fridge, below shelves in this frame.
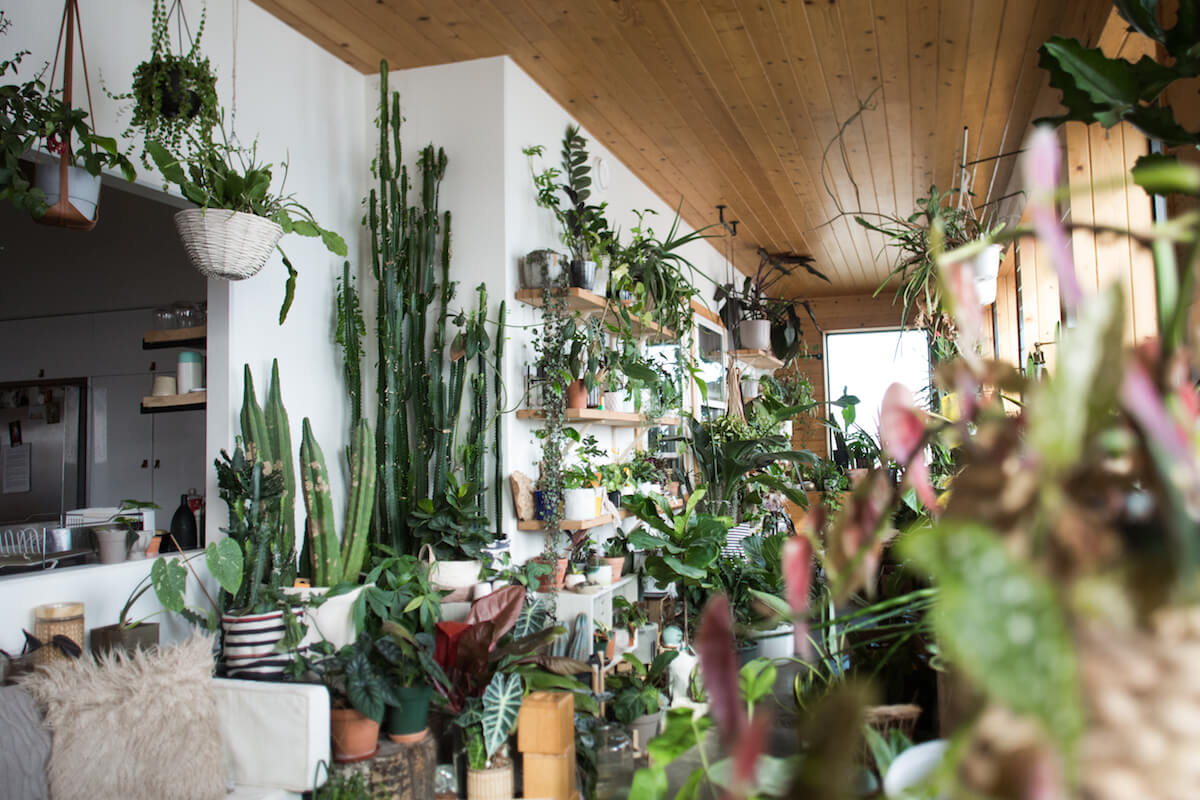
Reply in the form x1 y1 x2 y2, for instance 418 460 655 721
88 373 205 513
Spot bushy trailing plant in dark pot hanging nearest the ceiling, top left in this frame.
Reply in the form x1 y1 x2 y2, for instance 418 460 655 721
109 0 221 167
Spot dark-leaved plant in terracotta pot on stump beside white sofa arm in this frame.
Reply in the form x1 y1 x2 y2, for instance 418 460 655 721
289 631 398 764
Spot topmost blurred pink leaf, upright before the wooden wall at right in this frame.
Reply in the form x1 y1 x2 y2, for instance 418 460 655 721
1021 125 1084 312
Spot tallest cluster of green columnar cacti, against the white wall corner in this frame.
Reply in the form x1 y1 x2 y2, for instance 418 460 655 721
367 62 502 558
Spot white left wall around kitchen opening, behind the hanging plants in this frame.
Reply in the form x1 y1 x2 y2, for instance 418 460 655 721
0 0 373 646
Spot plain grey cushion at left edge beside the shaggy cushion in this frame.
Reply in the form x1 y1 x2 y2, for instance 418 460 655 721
0 686 50 800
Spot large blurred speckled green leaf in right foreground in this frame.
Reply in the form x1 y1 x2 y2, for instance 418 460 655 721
900 521 1084 750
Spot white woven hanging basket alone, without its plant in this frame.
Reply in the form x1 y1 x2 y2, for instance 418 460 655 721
175 209 283 281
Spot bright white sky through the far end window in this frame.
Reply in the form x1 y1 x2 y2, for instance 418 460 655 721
824 330 929 440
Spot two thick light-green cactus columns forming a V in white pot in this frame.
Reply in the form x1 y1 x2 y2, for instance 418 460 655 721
300 417 376 587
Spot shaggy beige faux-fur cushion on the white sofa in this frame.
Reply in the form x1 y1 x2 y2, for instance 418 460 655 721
22 636 226 800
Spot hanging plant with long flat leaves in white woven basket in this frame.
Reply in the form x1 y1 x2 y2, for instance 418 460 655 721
146 128 347 324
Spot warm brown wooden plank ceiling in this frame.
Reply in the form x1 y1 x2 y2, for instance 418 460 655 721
254 0 1111 296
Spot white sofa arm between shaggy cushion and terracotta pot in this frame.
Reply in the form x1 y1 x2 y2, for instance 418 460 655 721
212 678 331 796
